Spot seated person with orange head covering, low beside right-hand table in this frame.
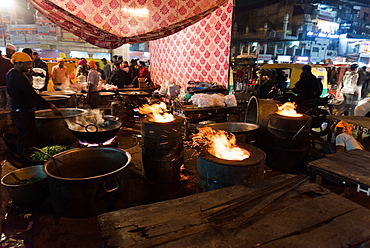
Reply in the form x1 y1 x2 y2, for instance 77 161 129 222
334 121 365 153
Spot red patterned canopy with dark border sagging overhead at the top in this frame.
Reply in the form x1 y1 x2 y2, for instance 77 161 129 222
28 0 227 49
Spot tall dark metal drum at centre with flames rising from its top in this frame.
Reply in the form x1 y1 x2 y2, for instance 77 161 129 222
141 116 185 183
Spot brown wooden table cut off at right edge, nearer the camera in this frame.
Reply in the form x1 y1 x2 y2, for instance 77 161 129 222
307 150 370 196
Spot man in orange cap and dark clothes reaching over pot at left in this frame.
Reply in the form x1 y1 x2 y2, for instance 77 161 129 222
6 52 61 167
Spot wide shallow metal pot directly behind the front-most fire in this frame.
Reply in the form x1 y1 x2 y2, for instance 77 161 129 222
197 122 260 143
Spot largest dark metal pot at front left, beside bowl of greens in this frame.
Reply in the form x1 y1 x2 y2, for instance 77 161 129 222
44 147 131 217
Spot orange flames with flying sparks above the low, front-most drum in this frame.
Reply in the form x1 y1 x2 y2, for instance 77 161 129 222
192 127 250 161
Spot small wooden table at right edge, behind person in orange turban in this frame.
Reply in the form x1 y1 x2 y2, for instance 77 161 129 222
326 115 370 142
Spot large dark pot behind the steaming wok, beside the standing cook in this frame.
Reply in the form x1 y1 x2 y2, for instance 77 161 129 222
35 108 86 147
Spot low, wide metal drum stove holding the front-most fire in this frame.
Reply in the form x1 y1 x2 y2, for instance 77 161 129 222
197 144 266 192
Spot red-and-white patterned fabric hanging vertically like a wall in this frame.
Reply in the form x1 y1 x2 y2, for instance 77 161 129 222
149 0 233 88
